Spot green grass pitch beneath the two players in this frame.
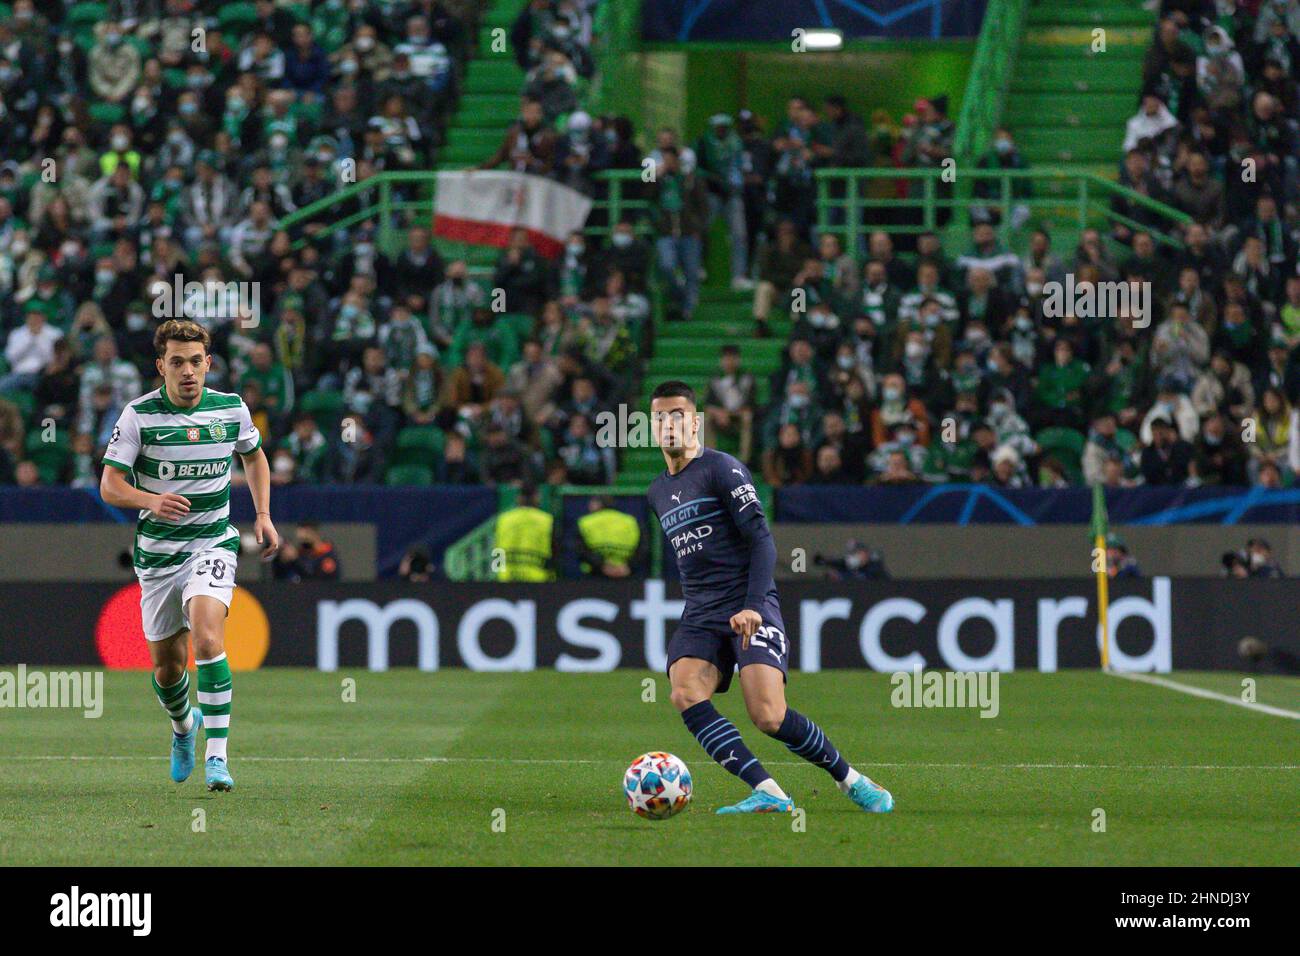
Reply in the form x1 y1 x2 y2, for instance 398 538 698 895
0 670 1300 866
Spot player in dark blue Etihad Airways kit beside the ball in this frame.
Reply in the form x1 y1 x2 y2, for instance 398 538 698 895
649 381 893 813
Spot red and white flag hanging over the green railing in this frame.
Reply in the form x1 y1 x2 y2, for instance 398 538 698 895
433 169 592 258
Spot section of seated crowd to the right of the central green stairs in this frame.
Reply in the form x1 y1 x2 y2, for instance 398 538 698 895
709 0 1300 488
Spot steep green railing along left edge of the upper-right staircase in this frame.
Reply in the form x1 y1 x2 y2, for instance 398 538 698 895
953 0 1028 165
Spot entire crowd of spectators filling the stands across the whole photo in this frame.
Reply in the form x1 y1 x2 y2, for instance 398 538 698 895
0 0 1300 488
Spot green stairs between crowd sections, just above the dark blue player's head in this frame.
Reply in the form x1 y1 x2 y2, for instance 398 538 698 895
615 286 790 494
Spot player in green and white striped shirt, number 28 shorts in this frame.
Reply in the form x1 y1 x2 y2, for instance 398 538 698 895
100 320 280 790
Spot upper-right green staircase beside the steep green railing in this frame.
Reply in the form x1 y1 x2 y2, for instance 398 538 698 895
1004 0 1154 179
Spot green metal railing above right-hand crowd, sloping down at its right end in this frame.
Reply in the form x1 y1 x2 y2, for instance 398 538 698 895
816 168 1192 251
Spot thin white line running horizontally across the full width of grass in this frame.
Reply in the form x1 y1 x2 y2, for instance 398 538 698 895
0 753 1300 770
